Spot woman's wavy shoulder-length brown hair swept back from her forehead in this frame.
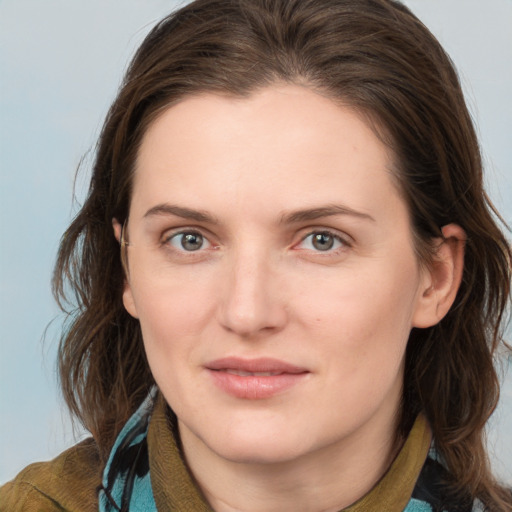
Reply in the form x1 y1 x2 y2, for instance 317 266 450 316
54 0 512 510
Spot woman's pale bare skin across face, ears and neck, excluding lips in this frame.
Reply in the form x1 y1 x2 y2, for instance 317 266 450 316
114 85 463 512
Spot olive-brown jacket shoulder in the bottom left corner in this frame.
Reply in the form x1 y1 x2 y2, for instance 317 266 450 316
0 438 102 512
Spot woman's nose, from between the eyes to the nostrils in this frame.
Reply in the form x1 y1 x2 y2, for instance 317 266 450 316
220 251 288 338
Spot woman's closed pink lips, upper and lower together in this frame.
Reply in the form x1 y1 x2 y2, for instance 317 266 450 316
205 357 310 400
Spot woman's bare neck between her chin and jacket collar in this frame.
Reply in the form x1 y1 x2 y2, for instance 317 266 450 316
179 408 402 512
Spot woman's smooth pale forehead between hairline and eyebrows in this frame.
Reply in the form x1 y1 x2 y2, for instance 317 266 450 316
133 85 404 224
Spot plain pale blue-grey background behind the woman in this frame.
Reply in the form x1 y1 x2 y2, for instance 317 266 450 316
0 0 512 483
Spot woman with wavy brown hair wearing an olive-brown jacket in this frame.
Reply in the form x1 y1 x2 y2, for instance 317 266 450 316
0 0 512 511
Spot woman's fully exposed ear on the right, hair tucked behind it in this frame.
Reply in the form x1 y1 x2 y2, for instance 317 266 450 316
412 224 466 328
